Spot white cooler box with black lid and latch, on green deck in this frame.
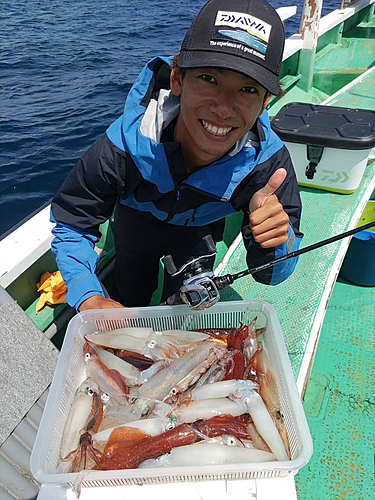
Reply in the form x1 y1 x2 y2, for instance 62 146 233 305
272 103 375 194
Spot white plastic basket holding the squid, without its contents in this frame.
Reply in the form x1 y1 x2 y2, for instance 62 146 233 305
31 301 312 486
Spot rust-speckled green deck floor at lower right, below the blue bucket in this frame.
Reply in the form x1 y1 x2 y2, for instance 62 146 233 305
295 278 375 500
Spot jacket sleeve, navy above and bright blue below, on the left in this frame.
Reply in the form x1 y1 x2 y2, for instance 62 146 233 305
51 134 125 310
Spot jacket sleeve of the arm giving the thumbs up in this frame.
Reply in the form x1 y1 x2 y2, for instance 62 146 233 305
242 146 303 285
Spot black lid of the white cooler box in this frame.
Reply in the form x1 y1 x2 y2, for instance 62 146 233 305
271 102 375 149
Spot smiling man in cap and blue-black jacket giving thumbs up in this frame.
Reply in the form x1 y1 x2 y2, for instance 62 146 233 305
51 0 302 311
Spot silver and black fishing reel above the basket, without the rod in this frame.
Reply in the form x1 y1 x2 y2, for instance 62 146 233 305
162 235 234 311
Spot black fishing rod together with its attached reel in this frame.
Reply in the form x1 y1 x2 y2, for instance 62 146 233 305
162 221 375 310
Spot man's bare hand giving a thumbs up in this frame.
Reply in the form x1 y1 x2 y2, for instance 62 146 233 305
249 168 289 248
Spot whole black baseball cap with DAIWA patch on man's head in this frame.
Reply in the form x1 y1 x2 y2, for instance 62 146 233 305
178 0 285 95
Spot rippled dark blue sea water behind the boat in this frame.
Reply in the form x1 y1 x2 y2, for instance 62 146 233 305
0 0 340 235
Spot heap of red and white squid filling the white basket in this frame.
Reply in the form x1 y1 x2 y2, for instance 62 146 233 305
61 318 289 472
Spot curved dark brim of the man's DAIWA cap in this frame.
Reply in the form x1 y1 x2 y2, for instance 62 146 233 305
178 50 280 95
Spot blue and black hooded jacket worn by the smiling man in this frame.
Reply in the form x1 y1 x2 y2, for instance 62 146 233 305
51 57 302 309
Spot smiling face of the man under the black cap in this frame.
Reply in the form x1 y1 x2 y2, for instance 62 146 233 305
171 68 269 169
